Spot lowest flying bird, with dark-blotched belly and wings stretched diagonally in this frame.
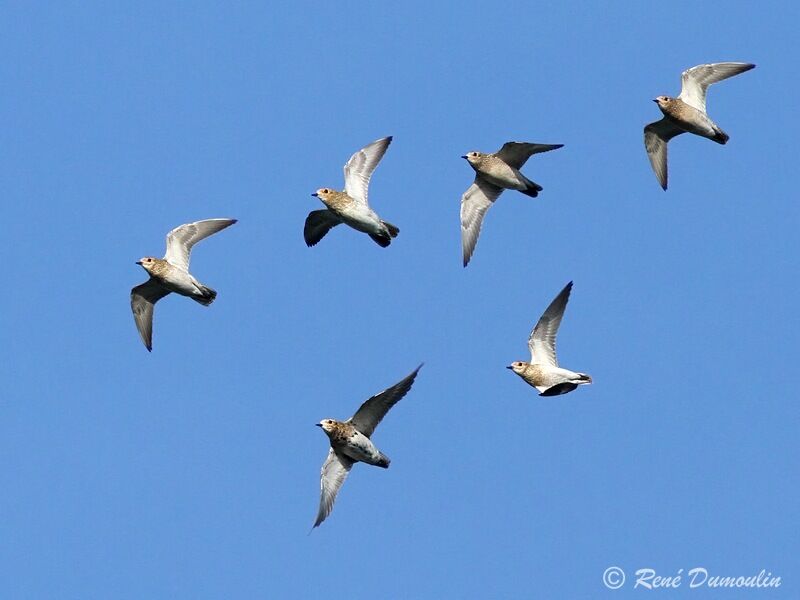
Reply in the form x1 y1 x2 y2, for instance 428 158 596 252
311 365 422 529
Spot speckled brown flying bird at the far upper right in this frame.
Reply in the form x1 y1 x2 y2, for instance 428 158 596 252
644 63 755 191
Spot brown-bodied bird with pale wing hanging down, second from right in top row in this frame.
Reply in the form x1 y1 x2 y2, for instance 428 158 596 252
461 142 564 267
